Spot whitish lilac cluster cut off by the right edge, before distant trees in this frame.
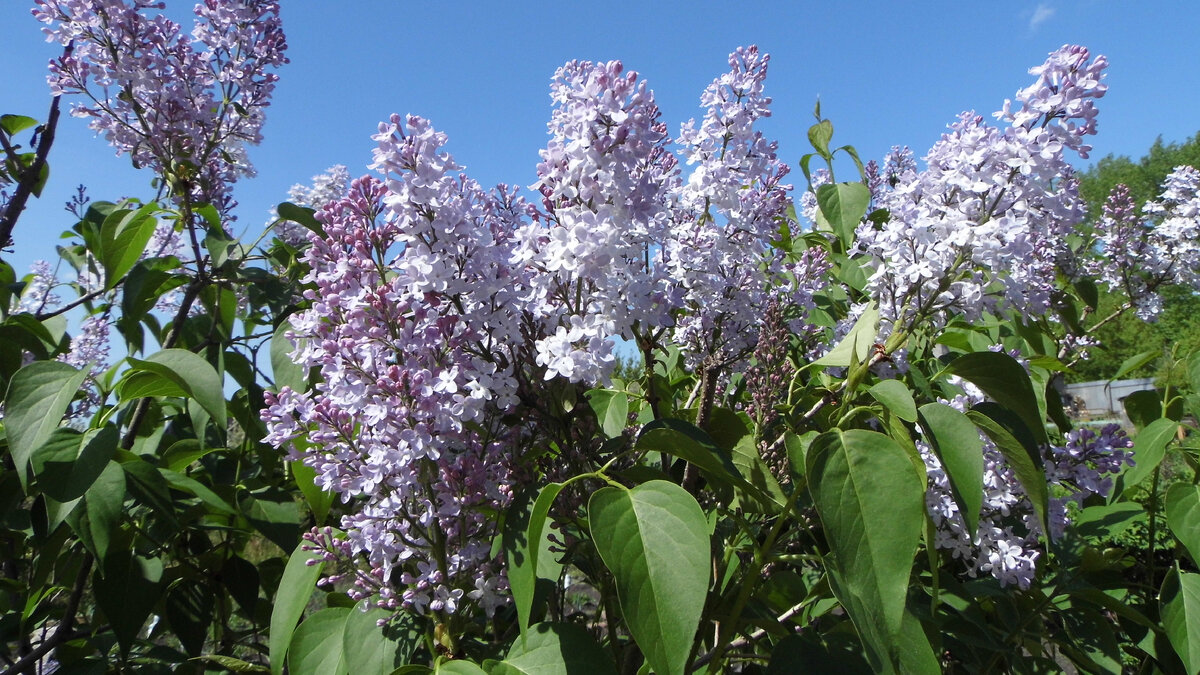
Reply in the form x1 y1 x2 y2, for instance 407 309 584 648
1097 166 1200 321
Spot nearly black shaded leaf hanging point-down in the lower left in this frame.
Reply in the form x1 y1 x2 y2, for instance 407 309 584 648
92 550 162 652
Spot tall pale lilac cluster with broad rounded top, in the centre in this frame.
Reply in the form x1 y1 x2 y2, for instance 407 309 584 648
512 61 678 382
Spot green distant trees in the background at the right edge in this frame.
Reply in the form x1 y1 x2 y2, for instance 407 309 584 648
1068 132 1200 382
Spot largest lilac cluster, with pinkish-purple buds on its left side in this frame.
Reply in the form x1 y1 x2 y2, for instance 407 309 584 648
265 117 528 613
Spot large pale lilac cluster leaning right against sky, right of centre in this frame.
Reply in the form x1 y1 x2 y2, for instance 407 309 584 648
858 46 1108 341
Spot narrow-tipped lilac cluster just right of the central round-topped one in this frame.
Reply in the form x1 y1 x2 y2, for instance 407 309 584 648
662 47 829 365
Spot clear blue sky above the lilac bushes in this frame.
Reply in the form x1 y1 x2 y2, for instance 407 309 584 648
0 0 1200 274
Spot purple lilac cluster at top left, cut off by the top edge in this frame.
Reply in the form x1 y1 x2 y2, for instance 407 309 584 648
34 0 287 211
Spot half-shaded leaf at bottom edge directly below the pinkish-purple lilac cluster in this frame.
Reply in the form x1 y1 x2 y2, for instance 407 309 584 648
342 601 422 675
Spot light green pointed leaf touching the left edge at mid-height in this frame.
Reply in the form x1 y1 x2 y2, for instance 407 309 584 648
4 362 88 488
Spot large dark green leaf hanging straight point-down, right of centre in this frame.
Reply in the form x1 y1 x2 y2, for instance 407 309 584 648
806 429 925 671
